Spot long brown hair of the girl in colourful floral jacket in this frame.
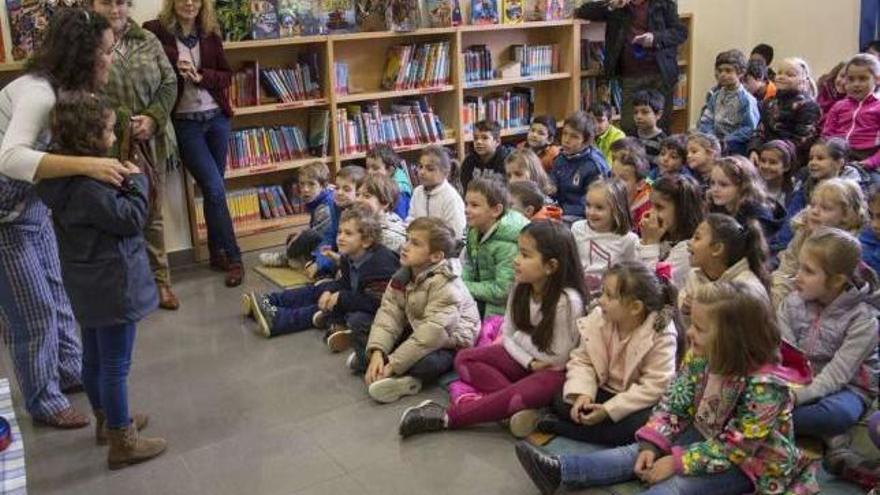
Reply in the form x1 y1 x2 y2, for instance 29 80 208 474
693 281 782 376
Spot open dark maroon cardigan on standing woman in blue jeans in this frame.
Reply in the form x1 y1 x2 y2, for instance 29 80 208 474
144 19 232 117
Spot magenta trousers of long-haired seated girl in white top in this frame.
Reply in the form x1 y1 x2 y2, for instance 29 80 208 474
446 344 565 428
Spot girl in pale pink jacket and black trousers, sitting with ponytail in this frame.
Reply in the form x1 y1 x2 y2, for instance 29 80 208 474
538 262 678 446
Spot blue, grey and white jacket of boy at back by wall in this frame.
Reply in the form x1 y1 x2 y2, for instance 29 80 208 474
697 84 761 155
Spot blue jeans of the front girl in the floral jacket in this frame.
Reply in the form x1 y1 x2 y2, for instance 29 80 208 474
559 428 753 495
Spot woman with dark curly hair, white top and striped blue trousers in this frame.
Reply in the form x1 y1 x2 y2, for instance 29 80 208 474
0 9 136 428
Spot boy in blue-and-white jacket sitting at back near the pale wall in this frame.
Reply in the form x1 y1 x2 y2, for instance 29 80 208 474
697 50 760 156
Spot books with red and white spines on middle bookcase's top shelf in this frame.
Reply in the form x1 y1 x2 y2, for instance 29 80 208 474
381 41 449 91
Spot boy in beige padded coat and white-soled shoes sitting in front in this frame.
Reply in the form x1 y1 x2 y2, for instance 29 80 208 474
360 217 480 403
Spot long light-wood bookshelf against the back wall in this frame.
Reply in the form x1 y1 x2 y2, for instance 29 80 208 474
0 14 693 261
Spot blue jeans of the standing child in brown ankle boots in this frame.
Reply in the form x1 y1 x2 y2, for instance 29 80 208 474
82 323 136 428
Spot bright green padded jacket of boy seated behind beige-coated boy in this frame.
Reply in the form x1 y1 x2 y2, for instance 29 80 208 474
461 209 529 318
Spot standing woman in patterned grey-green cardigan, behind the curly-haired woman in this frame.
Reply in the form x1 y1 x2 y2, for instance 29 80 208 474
91 0 180 310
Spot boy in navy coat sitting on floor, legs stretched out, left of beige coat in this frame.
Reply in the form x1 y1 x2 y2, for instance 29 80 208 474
242 205 400 340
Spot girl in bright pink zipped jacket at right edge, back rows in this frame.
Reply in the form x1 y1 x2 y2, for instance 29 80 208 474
822 53 880 171
